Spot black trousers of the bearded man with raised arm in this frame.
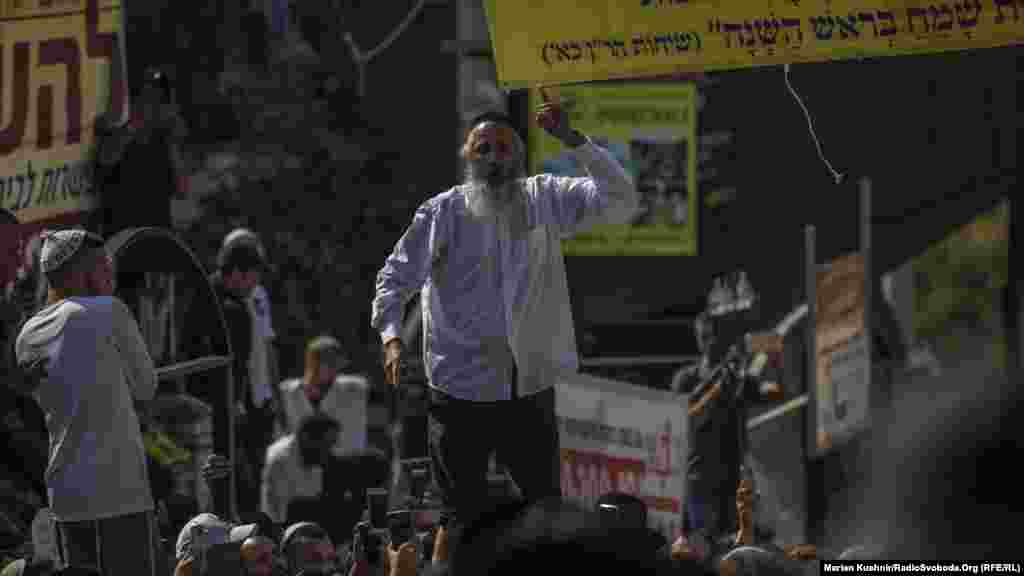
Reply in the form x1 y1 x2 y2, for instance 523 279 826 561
429 388 561 524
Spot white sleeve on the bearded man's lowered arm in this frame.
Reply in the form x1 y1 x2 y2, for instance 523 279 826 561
371 201 438 342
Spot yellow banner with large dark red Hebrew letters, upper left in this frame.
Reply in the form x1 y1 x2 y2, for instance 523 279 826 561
0 0 128 222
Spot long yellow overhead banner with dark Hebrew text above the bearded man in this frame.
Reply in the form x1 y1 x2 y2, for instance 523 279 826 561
484 0 1024 88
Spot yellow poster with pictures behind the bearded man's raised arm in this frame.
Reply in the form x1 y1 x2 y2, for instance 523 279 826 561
529 83 697 256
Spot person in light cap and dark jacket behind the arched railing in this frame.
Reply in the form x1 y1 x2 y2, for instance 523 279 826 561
204 237 273 510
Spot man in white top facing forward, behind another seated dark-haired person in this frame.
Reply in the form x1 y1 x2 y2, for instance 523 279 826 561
281 336 370 456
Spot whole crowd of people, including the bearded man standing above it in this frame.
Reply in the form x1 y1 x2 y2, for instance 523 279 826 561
4 81 1015 576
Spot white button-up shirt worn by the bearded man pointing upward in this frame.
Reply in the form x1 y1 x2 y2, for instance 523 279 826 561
372 140 638 402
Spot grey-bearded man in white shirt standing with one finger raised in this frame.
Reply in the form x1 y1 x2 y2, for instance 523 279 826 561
371 96 638 519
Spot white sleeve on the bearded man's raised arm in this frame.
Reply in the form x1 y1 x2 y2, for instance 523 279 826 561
530 139 640 236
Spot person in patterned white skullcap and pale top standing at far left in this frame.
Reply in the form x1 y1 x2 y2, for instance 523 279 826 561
15 230 160 576
